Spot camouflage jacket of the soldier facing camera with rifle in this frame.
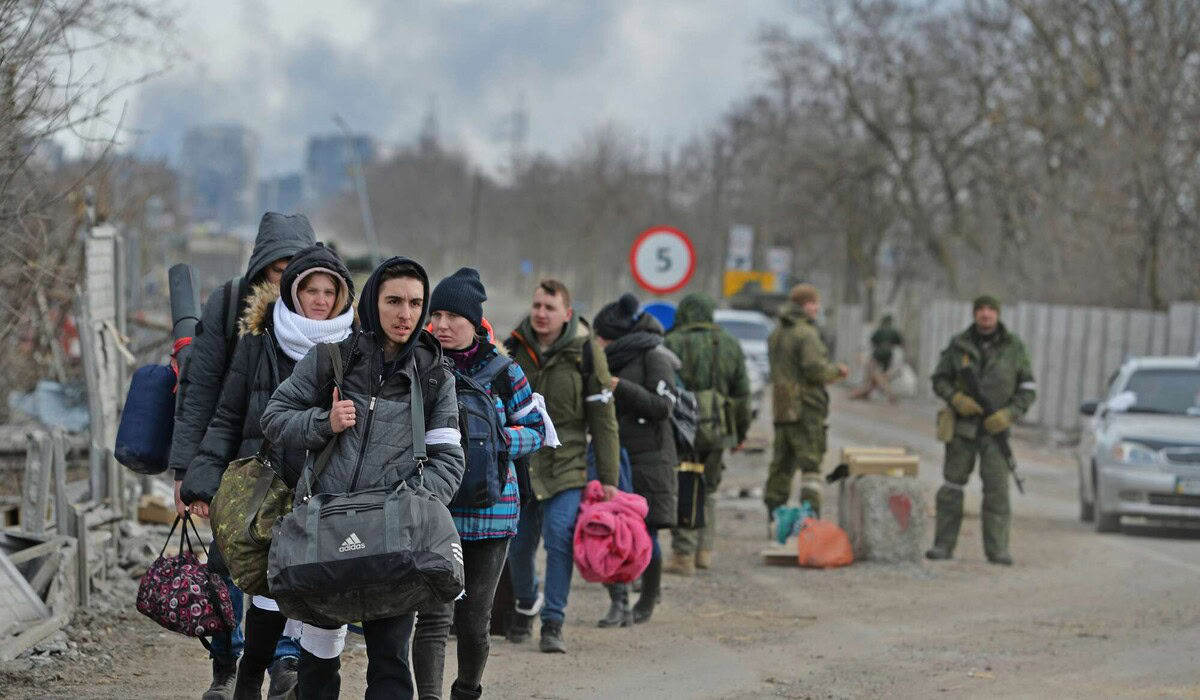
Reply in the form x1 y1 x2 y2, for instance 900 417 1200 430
932 323 1038 439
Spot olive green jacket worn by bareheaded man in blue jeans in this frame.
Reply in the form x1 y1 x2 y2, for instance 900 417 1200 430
508 315 620 501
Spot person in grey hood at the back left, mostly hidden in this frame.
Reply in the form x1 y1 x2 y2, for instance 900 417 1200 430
169 211 317 700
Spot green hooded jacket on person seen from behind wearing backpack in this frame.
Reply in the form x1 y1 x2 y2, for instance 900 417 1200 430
664 294 750 447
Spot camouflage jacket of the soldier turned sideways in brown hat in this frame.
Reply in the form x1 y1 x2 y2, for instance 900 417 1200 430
767 303 841 424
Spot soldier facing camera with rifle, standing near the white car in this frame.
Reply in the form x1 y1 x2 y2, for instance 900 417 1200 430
925 297 1037 566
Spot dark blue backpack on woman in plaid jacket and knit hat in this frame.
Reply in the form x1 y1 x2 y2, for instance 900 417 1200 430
450 355 512 508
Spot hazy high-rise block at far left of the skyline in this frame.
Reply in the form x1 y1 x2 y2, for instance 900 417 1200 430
180 124 259 227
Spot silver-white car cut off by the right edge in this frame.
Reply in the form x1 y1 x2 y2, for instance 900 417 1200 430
1079 358 1200 532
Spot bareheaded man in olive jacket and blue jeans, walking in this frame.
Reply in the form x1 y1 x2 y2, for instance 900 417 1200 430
505 280 620 653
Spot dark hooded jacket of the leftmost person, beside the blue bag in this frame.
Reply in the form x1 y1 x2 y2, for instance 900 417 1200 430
169 211 317 480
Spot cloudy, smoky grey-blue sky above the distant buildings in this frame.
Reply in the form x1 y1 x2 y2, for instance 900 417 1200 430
128 0 799 174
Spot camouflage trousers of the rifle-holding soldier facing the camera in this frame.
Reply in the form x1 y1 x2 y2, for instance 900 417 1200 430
934 435 1012 558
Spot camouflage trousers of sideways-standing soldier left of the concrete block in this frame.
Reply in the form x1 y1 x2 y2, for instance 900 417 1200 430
762 415 826 513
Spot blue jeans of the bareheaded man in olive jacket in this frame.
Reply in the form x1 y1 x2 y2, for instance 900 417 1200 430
509 489 583 622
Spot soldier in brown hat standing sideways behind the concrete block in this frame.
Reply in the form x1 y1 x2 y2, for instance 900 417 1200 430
763 285 850 519
